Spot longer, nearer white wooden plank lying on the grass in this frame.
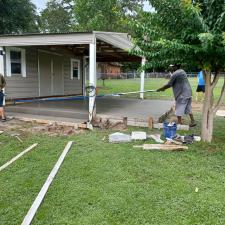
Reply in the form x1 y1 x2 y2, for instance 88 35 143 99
21 141 73 225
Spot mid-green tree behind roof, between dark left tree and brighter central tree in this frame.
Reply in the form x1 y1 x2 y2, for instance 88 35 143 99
39 0 73 33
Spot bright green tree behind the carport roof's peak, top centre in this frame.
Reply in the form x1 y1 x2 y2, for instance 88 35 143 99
73 0 143 32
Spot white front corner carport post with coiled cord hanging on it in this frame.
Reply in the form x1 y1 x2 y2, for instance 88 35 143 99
89 37 96 122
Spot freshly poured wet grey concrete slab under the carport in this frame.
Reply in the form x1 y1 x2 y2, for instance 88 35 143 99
6 98 173 120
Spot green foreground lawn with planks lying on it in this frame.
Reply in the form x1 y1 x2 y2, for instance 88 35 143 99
0 115 225 225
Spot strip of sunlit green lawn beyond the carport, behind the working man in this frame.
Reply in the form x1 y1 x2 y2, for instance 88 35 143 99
97 78 223 103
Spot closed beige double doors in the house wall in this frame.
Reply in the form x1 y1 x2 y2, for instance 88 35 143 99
39 52 64 97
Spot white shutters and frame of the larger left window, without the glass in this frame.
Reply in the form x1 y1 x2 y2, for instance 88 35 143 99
6 47 27 77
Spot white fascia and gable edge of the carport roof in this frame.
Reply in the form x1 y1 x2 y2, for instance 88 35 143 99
0 31 133 50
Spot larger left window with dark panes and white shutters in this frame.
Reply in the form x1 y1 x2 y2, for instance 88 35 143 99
6 48 26 77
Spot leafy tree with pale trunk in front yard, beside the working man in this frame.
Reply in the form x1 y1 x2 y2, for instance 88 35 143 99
133 0 225 142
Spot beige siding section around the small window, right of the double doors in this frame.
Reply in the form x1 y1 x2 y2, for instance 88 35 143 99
63 57 83 95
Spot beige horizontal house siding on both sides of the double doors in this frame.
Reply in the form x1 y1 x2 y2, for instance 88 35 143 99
5 47 83 100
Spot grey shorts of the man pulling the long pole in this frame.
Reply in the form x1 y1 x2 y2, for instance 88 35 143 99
176 98 192 116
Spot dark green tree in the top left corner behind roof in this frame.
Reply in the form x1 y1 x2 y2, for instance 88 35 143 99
0 0 38 34
